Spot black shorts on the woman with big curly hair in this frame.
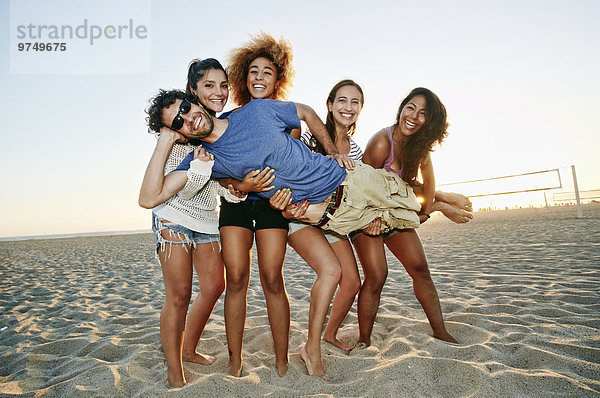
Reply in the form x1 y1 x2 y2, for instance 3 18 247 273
219 198 289 232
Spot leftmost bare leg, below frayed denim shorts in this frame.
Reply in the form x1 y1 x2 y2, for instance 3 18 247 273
158 236 192 387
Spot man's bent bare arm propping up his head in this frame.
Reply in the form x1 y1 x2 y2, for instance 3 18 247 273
138 129 187 209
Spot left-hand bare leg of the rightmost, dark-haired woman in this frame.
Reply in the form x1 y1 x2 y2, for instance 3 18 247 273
353 234 388 346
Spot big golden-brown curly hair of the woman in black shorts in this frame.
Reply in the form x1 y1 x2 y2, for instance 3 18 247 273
227 32 296 106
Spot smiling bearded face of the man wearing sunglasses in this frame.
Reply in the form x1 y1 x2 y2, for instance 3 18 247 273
161 99 214 139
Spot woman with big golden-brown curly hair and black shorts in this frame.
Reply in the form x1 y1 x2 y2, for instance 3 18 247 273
219 33 294 376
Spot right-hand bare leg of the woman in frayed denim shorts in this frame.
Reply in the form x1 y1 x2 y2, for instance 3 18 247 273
182 242 225 365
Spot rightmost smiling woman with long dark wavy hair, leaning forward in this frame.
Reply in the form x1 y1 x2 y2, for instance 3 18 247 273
353 87 466 346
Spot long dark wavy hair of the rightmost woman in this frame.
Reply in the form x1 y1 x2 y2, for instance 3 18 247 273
393 87 448 185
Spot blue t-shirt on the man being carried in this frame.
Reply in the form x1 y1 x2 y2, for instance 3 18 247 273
177 99 346 203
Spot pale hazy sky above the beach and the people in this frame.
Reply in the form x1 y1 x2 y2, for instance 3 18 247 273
0 0 600 237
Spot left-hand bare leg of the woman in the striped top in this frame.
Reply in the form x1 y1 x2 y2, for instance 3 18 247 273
288 227 341 378
